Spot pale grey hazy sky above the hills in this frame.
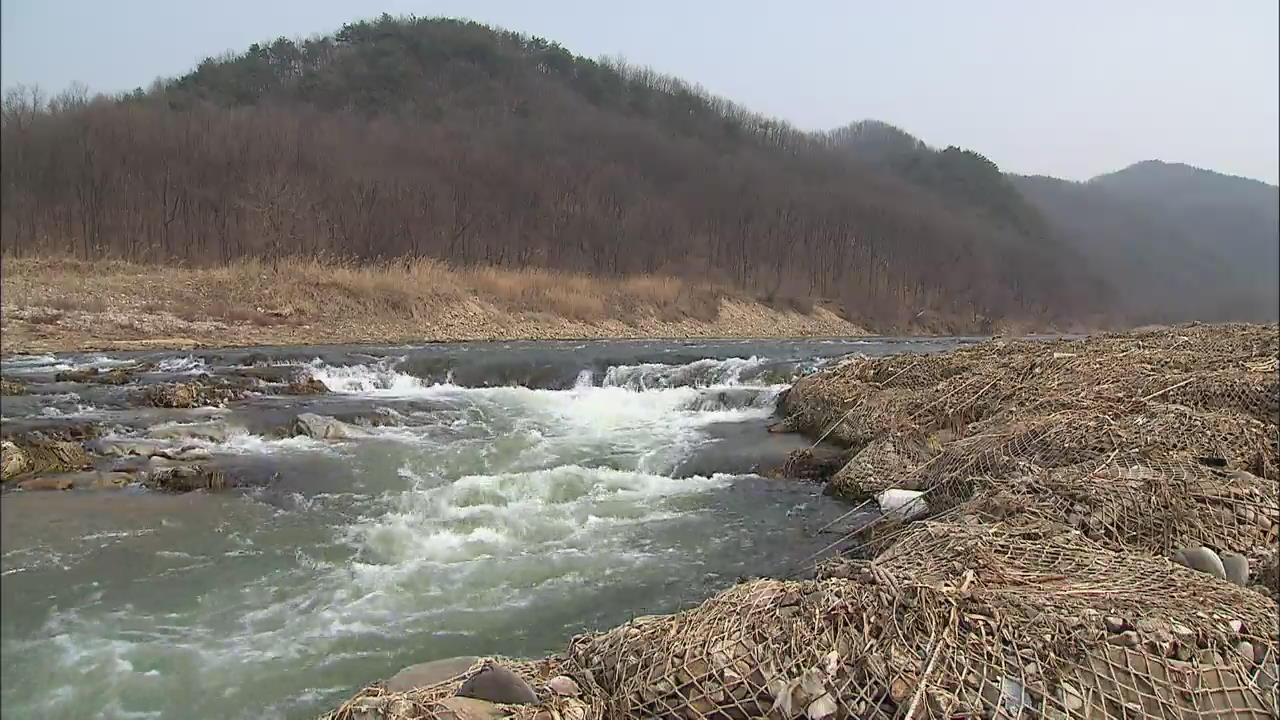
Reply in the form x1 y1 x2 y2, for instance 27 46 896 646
0 0 1280 183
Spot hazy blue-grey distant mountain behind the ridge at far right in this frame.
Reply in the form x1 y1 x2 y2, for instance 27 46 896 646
1014 160 1280 323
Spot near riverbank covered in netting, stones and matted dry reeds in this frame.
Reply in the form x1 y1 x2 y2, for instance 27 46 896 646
322 325 1280 720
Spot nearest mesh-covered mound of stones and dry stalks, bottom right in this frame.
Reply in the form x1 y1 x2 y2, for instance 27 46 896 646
568 521 1280 719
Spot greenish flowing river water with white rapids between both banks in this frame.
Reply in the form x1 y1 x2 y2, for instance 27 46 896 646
0 340 964 719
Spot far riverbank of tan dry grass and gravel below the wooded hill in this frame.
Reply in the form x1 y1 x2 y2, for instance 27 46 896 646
0 258 868 354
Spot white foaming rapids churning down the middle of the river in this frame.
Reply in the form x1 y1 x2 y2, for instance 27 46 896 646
4 357 829 717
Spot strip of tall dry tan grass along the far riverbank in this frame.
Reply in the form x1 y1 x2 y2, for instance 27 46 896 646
4 259 739 325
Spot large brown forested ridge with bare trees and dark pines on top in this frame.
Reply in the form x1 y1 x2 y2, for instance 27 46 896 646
0 15 1274 331
